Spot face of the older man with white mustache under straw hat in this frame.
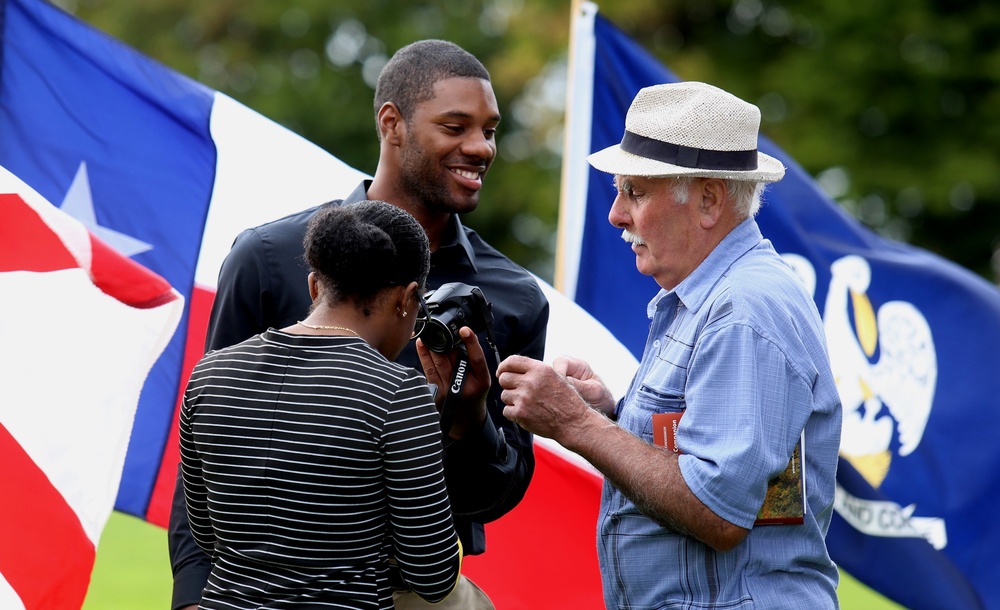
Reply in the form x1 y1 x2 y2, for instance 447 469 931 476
608 176 717 290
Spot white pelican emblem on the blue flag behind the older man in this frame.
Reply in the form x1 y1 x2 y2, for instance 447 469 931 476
785 255 938 488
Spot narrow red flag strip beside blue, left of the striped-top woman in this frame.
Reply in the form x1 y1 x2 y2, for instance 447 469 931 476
146 286 215 527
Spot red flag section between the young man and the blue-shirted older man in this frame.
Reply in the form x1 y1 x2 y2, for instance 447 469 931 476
462 443 604 610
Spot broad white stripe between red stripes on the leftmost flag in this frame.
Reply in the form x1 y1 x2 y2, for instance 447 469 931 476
0 268 179 544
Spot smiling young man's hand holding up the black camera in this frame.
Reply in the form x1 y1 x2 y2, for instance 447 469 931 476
417 326 492 440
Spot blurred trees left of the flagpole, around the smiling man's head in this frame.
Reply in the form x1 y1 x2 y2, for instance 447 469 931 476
66 0 570 279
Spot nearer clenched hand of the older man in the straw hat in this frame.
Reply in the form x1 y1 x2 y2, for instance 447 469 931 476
497 356 594 445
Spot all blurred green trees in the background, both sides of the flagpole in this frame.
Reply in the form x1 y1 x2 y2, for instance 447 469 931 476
61 0 1000 281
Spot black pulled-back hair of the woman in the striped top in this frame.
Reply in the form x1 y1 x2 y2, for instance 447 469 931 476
303 200 431 315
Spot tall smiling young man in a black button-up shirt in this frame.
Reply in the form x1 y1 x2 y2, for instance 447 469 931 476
169 40 549 610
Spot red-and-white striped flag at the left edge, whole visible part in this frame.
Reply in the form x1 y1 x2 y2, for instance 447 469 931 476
0 167 184 609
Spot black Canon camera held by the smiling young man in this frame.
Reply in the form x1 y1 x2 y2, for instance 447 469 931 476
419 282 493 353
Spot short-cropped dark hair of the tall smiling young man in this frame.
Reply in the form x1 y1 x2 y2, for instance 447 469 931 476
375 39 490 120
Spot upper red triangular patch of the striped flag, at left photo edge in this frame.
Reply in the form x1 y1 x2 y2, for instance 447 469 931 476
0 193 79 272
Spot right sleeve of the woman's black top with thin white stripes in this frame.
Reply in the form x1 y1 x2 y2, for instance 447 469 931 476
382 374 462 603
